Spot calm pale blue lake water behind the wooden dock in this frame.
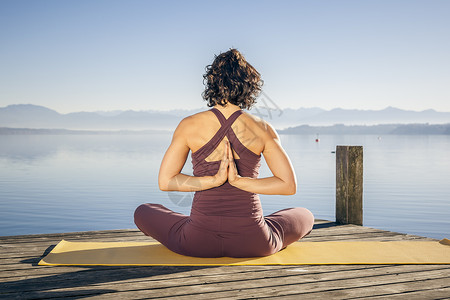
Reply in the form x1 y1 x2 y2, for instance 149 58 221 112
0 134 450 239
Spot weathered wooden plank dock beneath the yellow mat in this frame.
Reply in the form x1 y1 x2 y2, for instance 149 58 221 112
0 220 450 299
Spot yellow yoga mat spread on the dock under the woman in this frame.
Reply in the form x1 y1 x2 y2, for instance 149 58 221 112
39 239 450 266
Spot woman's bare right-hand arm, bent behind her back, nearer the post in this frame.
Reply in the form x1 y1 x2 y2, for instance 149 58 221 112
228 126 297 195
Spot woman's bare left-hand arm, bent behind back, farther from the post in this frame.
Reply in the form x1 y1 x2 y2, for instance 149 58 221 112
158 120 228 192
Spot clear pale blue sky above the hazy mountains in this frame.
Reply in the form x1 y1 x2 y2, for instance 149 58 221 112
0 0 450 113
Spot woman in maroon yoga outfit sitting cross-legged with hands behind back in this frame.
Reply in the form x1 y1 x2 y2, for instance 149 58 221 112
135 49 314 257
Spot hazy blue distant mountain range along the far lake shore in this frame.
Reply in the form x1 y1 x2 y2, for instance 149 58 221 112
0 104 450 131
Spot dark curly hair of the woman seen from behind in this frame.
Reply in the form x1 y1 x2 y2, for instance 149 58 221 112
202 49 264 109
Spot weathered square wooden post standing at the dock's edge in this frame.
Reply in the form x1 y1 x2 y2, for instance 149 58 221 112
336 146 363 225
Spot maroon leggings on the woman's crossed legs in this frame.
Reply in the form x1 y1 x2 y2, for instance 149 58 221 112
134 203 314 257
